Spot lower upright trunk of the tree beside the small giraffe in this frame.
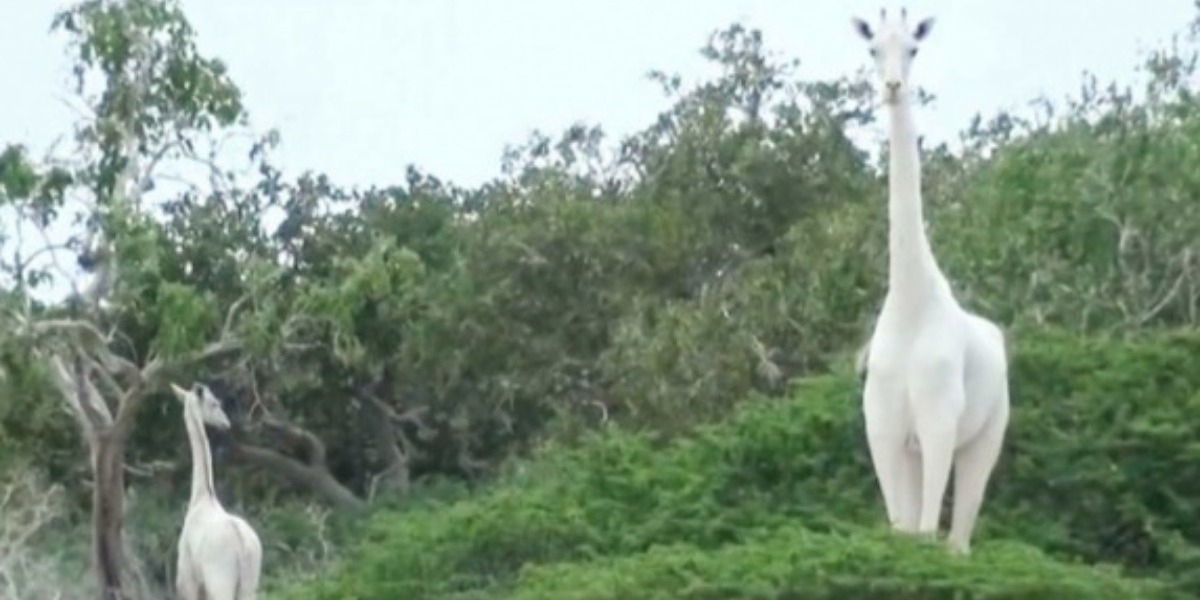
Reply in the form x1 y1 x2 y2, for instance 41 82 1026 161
91 428 132 600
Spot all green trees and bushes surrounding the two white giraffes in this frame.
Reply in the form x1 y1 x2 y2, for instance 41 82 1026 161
7 0 1200 600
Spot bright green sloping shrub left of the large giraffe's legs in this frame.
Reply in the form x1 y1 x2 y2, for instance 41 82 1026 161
282 378 874 598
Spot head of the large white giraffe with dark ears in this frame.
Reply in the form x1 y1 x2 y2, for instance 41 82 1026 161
852 8 934 104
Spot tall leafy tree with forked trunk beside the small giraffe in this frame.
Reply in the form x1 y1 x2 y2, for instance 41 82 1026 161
4 0 264 600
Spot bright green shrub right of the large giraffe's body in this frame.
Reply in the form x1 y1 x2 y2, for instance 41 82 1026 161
984 331 1200 583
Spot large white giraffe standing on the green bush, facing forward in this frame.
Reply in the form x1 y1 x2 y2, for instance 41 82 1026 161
853 10 1009 553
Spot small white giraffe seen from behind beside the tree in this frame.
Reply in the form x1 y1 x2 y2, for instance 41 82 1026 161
170 384 263 600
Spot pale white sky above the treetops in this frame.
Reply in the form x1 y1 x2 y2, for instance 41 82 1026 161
0 0 1195 298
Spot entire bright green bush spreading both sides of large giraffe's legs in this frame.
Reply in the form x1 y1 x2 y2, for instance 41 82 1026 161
276 331 1200 600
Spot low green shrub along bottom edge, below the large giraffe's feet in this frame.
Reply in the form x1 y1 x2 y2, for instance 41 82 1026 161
480 527 1183 600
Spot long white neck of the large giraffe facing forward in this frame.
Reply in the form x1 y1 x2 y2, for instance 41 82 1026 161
888 98 943 306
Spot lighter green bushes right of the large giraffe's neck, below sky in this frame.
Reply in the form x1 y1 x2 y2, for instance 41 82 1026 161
931 53 1200 331
